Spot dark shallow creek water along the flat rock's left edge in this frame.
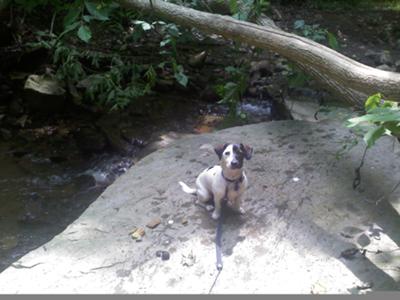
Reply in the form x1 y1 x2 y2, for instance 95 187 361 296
0 143 132 271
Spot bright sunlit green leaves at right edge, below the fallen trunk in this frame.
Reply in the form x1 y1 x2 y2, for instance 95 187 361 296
346 93 400 148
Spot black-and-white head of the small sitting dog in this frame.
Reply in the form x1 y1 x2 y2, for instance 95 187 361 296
214 144 253 169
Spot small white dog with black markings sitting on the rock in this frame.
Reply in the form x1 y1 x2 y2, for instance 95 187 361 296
179 144 253 220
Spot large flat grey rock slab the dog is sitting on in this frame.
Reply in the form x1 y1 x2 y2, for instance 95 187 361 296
0 121 400 294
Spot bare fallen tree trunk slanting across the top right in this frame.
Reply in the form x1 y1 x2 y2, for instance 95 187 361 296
120 0 400 106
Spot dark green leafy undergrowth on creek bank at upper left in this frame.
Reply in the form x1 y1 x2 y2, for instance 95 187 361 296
14 0 193 110
